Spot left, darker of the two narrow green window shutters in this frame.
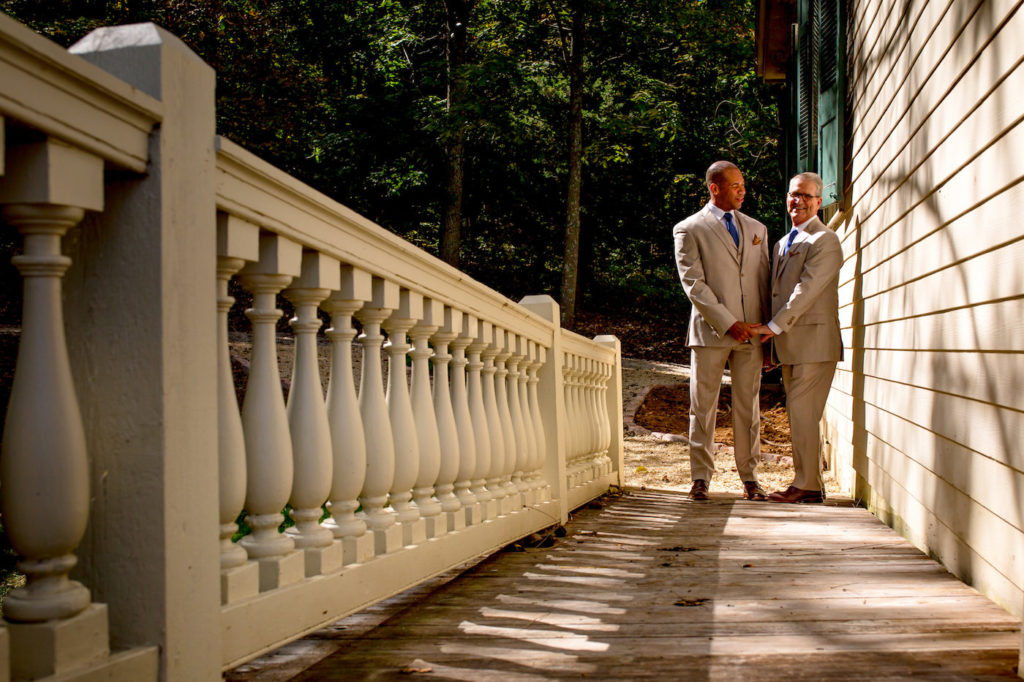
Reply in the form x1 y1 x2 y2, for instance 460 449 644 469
797 0 818 172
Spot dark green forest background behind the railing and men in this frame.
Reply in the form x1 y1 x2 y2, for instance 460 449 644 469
0 0 784 361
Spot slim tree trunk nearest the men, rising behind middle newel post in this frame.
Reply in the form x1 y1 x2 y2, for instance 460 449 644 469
561 0 583 327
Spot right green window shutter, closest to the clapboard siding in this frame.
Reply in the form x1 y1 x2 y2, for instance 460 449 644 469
815 0 846 206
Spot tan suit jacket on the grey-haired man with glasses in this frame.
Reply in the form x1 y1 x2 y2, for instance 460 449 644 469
771 217 843 365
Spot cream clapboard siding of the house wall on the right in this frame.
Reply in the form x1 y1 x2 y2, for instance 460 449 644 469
824 0 1024 614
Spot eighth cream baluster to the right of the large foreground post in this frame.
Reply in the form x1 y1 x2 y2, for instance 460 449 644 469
431 306 466 530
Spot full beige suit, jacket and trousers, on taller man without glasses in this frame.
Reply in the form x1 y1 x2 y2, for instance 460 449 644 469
673 206 769 481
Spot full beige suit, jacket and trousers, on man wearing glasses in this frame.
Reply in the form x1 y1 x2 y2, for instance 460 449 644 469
771 218 843 491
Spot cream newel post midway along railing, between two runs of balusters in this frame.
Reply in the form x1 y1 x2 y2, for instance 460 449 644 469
519 296 569 523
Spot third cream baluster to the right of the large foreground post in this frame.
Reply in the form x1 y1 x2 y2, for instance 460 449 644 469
285 251 342 577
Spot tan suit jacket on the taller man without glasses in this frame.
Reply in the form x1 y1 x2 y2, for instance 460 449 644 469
672 200 769 339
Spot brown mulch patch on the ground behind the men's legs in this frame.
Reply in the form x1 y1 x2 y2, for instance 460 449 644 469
633 383 793 455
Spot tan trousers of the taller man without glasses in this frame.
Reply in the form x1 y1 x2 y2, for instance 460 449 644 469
689 343 761 482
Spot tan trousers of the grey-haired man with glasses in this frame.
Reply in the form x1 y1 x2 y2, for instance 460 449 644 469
782 363 838 491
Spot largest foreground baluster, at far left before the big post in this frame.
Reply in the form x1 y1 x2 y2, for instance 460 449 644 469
0 201 90 622
